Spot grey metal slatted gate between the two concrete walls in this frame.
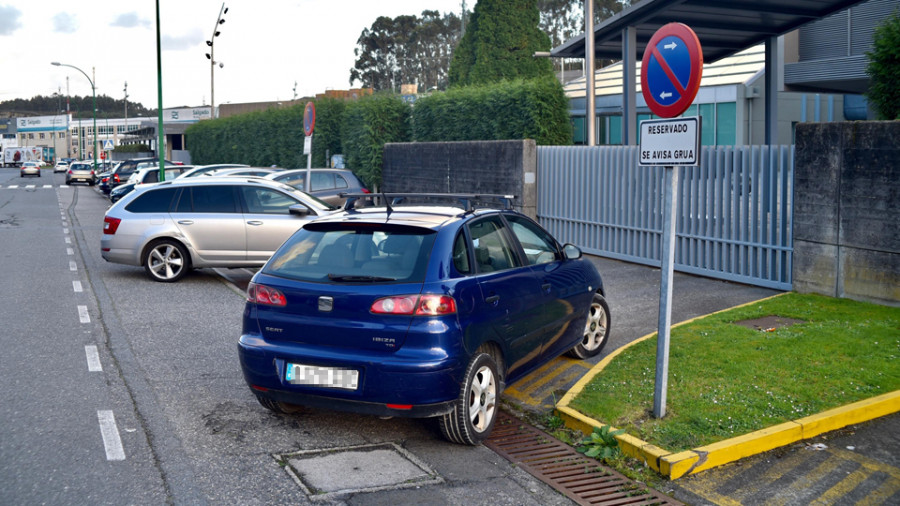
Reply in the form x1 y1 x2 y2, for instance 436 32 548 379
537 146 794 290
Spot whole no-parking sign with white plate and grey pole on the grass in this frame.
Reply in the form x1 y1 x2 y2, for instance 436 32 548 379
639 23 703 418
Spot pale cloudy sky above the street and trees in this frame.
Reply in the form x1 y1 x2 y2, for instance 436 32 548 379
0 0 475 114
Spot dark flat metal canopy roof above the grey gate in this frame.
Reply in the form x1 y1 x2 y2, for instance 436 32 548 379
550 0 876 62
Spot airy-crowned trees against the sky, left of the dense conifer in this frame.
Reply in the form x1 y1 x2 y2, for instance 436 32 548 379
350 11 462 91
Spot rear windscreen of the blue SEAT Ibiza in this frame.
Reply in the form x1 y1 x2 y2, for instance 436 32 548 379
263 223 435 284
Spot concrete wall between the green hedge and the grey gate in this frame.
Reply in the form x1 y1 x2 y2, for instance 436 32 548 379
382 139 537 219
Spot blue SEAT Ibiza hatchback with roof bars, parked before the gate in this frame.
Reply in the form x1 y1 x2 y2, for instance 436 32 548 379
238 194 610 444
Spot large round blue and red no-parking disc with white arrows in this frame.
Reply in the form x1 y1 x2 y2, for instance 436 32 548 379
641 23 703 118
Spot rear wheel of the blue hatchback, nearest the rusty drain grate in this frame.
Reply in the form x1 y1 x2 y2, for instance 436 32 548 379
439 352 500 445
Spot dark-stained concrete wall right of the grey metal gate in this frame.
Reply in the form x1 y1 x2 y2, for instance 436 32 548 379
793 121 900 306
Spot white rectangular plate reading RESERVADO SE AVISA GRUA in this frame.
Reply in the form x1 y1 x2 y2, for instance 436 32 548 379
638 116 700 165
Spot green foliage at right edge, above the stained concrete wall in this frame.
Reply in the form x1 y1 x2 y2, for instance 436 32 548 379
866 9 900 120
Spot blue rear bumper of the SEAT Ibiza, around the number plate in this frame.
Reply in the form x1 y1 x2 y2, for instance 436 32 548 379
238 334 465 418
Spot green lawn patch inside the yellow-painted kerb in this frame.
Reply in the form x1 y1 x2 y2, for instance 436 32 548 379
571 293 900 452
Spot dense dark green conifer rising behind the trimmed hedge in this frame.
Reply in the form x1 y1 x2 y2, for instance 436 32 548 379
450 0 553 85
